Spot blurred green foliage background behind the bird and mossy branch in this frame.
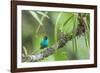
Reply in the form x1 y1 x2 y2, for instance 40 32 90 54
22 10 90 62
